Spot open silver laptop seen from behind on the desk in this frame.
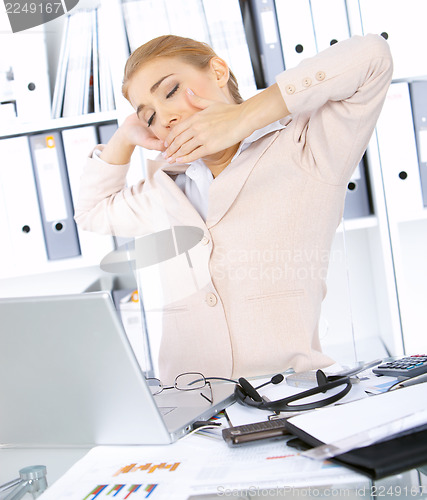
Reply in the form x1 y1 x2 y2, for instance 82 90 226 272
0 292 234 446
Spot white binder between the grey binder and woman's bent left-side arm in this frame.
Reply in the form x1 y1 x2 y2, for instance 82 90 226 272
62 125 114 264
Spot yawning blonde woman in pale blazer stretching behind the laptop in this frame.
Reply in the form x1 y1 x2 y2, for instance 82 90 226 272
76 35 392 380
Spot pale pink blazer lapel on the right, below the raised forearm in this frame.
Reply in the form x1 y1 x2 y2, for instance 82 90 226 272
206 131 279 229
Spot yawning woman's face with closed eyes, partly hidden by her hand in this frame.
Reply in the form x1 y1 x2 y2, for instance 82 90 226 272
128 57 232 140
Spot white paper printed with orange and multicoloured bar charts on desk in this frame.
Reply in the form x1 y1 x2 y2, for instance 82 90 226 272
40 436 369 500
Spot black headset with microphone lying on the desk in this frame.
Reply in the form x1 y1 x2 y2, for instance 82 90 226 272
234 370 351 412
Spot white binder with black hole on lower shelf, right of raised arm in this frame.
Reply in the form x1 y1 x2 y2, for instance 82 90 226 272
377 82 423 221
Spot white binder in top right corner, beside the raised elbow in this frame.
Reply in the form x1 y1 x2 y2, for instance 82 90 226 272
359 0 427 79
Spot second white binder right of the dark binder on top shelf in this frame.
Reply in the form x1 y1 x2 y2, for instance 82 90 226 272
310 0 350 52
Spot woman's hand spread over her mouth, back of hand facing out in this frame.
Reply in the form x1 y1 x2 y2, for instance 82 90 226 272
163 90 249 163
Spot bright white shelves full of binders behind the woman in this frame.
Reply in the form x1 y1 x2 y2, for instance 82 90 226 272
0 0 427 363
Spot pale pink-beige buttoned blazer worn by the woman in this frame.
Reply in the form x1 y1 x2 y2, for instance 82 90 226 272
75 35 392 381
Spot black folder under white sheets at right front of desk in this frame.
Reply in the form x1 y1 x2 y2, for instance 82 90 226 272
287 424 427 480
